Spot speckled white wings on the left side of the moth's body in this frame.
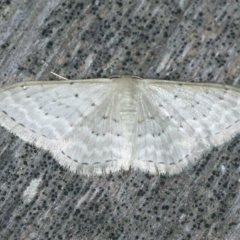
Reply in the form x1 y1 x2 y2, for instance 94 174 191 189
0 79 124 174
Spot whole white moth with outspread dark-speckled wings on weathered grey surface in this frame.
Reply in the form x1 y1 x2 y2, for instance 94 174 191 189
0 77 240 175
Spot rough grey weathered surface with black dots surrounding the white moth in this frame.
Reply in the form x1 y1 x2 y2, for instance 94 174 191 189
0 0 240 240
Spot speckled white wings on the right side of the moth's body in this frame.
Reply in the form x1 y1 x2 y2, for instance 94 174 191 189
133 79 240 174
